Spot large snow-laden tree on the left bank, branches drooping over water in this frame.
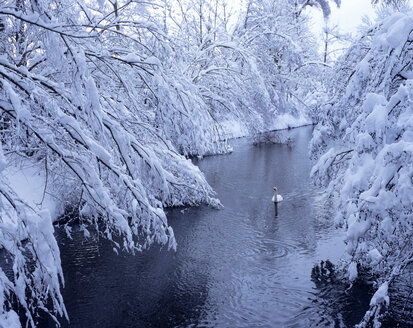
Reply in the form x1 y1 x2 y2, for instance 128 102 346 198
0 0 222 326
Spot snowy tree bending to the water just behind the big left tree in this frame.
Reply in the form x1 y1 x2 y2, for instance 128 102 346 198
121 0 236 156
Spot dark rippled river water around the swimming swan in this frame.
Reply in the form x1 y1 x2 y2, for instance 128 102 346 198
39 127 408 328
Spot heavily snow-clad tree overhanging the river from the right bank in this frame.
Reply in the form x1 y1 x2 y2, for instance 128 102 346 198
311 12 413 327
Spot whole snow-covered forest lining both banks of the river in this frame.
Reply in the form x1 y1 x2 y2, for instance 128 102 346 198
0 0 413 327
